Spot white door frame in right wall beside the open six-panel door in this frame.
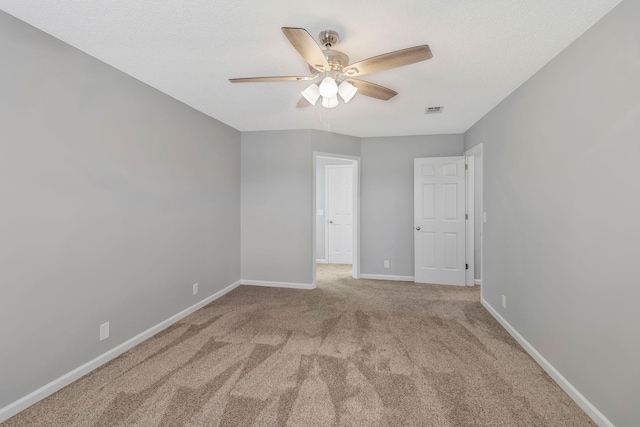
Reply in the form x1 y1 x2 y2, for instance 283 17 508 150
464 144 484 292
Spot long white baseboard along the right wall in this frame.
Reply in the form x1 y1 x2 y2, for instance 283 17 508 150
481 298 615 427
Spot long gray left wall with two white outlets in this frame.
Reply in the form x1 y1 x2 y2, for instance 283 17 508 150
0 12 240 408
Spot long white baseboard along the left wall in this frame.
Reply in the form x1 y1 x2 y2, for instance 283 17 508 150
0 281 240 423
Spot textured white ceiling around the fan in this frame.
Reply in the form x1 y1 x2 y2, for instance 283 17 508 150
0 0 620 136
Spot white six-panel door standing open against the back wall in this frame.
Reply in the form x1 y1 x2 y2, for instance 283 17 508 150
414 157 466 286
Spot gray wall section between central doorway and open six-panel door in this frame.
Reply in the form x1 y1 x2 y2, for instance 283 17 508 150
360 134 464 276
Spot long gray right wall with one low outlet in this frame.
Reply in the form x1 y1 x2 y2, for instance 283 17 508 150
464 0 640 426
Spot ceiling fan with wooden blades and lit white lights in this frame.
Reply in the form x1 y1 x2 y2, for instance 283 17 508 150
229 27 433 108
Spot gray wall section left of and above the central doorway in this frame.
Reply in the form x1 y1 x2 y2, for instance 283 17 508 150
241 130 360 284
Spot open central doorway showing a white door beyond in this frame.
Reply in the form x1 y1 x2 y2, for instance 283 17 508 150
313 153 359 284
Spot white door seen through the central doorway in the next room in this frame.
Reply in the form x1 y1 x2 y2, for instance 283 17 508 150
325 165 353 264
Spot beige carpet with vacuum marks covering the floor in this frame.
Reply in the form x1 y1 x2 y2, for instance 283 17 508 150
6 265 595 426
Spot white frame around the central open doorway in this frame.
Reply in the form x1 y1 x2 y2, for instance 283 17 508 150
311 151 360 287
